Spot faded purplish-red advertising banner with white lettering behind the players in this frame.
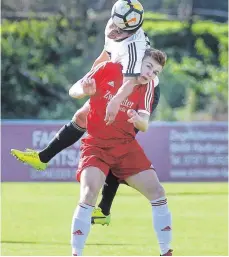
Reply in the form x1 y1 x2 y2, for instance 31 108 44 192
1 121 228 182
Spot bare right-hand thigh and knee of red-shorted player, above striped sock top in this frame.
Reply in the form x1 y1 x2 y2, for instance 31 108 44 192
125 169 165 201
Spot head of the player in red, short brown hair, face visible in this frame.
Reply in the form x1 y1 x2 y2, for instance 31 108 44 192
138 48 167 84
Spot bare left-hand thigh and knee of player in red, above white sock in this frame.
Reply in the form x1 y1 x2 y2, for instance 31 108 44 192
80 167 106 205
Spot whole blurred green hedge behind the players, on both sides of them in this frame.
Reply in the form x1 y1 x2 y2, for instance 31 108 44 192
1 12 228 120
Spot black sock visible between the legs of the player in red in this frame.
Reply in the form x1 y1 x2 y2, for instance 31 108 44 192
98 171 119 215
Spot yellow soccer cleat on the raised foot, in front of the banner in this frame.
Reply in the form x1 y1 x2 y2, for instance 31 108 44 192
11 149 48 170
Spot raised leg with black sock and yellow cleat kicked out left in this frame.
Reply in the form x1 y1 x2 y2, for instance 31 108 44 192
11 102 89 170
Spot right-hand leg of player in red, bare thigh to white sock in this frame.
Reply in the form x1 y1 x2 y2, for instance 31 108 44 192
126 169 172 256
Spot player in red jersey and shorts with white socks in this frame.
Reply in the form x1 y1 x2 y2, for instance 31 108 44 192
69 49 172 256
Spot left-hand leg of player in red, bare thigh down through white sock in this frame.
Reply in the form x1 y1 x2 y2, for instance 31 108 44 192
71 167 106 256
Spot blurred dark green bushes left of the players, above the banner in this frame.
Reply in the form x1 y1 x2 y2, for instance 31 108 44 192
1 16 94 119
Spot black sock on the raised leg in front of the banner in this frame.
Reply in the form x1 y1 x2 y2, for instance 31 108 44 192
39 121 86 163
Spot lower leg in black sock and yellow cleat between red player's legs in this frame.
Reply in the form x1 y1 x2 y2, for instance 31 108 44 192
91 171 119 225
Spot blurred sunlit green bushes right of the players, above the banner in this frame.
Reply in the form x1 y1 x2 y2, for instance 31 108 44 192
141 14 228 120
